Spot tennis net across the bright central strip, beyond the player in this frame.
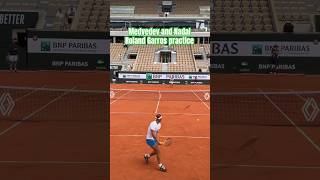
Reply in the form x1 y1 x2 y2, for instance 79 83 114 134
110 89 210 103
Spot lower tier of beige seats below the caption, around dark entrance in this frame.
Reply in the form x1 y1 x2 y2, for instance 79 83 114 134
110 43 210 72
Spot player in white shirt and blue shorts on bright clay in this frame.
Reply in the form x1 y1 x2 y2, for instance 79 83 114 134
144 114 167 172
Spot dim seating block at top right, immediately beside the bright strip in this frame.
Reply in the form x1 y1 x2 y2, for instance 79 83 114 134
211 0 274 32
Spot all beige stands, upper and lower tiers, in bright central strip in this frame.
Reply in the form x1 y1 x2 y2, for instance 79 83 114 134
110 0 210 72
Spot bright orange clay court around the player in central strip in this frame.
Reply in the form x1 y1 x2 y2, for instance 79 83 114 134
110 84 210 180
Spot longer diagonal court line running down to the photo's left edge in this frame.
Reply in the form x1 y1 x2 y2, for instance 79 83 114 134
0 87 76 136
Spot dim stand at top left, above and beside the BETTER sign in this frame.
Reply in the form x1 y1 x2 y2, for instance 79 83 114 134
0 0 109 31
